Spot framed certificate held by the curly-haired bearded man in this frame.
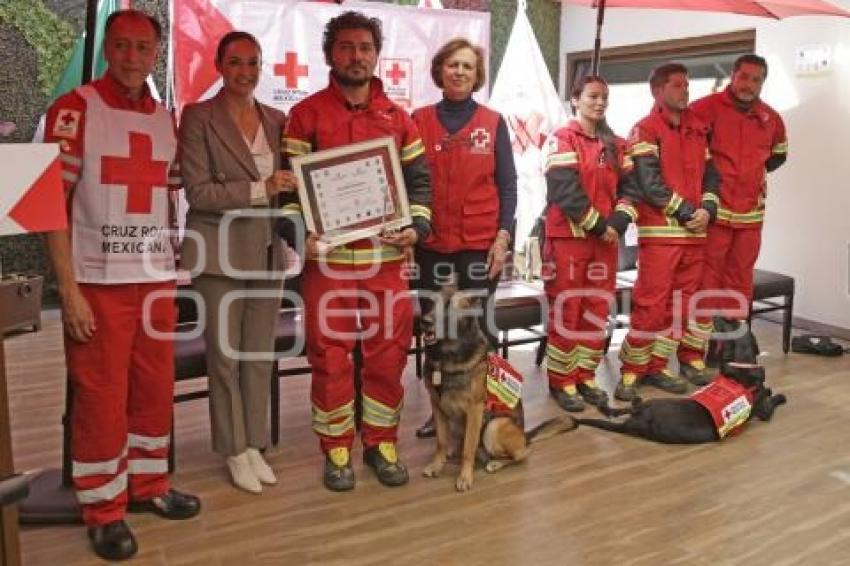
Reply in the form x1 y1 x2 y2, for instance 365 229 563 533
291 137 410 246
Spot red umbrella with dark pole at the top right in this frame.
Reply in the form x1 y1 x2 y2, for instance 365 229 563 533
562 0 850 74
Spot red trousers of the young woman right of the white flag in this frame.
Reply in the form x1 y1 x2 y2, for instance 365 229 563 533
543 238 617 389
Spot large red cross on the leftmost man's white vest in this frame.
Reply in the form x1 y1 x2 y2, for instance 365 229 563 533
100 132 168 214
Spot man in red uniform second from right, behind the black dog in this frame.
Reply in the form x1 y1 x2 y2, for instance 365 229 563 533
614 63 719 401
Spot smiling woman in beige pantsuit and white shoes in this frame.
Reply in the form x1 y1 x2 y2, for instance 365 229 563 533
179 31 295 493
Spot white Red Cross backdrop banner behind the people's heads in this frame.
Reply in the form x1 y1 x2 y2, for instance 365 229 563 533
171 0 490 113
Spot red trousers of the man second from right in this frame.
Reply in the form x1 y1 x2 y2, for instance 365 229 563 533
620 244 705 376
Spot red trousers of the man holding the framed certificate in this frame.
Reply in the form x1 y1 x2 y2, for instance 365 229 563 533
302 261 413 452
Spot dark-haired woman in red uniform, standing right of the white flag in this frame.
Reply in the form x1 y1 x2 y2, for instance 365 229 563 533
543 76 631 412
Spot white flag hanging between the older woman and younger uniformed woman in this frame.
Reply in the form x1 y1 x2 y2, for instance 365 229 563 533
488 0 567 250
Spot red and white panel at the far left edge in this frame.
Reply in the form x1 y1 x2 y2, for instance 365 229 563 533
0 143 68 236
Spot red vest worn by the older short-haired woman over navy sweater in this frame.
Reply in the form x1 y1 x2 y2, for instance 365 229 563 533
413 105 499 253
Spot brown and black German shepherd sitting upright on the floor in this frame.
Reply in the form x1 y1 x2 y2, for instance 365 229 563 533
420 287 577 491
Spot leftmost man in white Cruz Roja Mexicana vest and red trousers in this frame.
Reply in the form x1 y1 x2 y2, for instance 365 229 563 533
45 10 200 560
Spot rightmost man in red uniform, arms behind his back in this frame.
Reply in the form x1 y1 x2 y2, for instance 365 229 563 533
679 54 788 384
